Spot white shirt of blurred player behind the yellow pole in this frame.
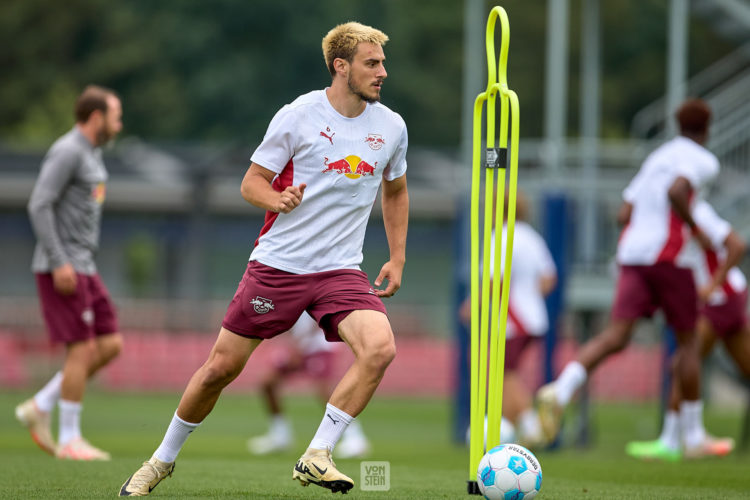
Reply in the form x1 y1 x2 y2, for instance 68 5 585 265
490 225 557 338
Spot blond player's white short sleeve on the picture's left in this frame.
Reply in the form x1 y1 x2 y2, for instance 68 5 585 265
250 105 299 174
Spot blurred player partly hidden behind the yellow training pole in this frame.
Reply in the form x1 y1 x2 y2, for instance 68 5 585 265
461 189 557 447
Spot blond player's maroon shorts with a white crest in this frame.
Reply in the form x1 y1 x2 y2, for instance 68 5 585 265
222 261 387 342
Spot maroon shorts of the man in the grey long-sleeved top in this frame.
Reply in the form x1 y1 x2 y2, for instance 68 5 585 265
36 273 118 344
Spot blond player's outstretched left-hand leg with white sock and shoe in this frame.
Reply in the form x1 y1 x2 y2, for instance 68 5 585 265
119 328 261 497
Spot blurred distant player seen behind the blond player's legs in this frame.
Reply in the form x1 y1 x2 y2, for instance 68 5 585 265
247 312 370 458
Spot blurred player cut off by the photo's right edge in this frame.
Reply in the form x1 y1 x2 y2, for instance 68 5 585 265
626 200 750 461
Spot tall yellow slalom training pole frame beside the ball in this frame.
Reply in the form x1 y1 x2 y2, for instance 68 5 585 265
468 7 519 494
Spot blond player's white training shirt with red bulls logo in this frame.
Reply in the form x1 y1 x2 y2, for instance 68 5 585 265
250 90 408 274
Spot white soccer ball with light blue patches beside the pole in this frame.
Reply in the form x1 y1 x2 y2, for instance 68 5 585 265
477 444 542 500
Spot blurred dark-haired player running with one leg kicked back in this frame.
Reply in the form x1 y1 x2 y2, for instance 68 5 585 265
537 99 719 458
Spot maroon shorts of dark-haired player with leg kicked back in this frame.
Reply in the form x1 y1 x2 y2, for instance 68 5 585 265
612 262 698 332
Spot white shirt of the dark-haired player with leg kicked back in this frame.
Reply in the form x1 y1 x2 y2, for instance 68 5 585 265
617 136 719 267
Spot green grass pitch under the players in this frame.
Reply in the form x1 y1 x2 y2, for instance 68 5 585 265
0 390 750 500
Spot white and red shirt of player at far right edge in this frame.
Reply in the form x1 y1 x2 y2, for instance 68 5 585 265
685 199 747 306
